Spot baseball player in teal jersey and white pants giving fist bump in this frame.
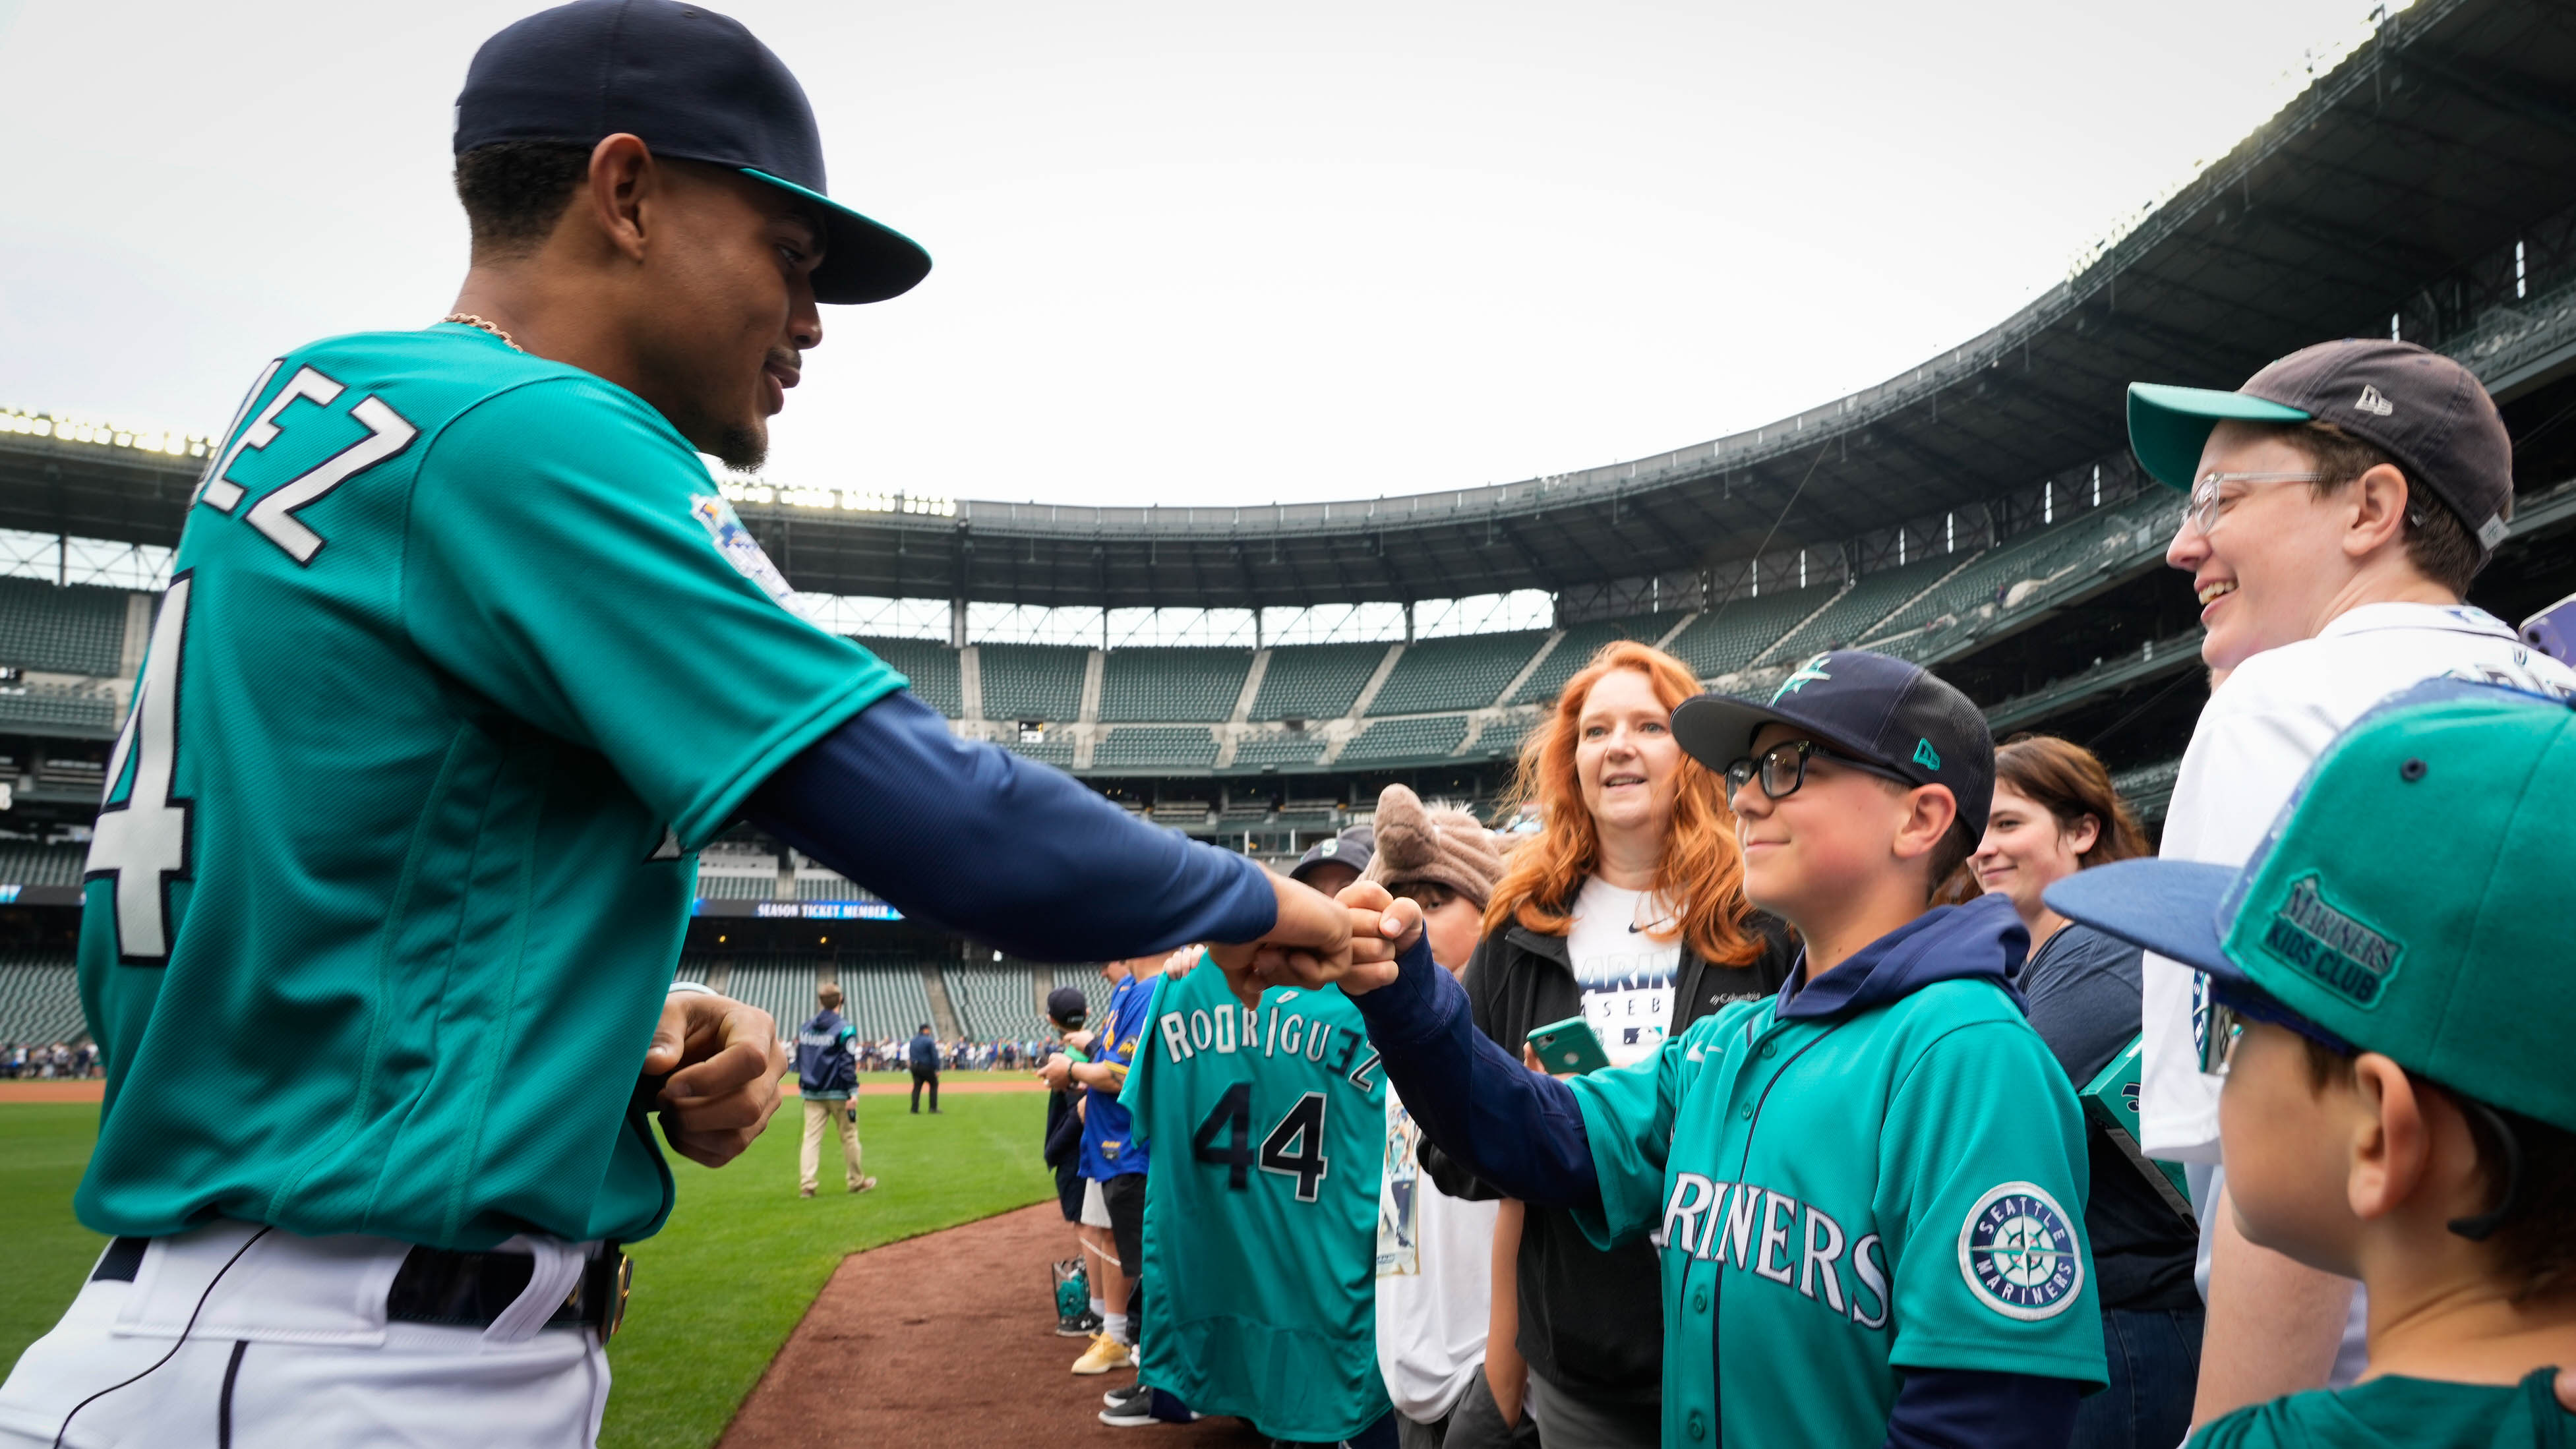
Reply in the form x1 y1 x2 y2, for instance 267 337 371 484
0 0 1347 1446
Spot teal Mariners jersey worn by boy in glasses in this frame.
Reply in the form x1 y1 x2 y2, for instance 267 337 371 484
1571 980 2105 1446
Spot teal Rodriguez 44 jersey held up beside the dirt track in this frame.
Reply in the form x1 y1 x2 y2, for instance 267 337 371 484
1125 962 1389 1444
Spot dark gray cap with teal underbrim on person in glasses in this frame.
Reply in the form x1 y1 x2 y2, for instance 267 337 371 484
2128 337 2514 553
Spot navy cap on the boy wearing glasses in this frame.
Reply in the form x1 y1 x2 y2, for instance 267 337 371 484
1672 649 1994 837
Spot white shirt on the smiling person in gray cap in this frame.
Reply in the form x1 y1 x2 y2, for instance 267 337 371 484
2132 605 2576 1164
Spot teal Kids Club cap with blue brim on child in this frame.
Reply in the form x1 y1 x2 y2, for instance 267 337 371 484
2045 680 2576 1130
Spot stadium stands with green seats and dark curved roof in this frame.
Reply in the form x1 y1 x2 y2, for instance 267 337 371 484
0 0 2576 821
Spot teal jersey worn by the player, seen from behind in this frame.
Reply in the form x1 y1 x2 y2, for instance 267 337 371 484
75 324 904 1248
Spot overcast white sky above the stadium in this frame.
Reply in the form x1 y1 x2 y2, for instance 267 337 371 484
0 0 2370 504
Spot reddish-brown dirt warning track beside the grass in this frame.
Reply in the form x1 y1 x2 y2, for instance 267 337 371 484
721 1202 1265 1449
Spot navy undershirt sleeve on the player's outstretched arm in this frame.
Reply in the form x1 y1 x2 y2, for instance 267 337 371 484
744 692 1278 960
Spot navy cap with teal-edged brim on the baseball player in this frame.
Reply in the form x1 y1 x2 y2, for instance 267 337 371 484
456 0 930 304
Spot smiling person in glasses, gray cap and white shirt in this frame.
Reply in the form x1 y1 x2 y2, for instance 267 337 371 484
2128 340 2576 1423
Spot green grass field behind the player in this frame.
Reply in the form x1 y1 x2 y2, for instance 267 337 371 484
0 1096 1054 1449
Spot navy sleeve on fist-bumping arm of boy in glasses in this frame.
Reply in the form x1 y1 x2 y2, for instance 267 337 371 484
1350 939 1600 1207
